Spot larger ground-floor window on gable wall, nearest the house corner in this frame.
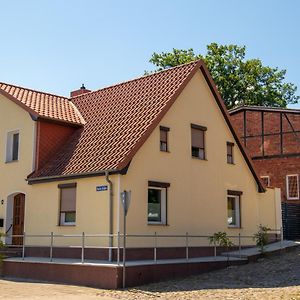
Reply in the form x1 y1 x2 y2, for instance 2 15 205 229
148 181 170 225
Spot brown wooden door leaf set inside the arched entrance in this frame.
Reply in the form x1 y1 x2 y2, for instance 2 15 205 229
12 194 25 245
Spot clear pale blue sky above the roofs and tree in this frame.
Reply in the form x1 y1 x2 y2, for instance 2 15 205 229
0 0 300 107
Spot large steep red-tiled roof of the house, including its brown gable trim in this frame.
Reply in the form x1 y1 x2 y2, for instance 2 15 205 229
2 60 265 191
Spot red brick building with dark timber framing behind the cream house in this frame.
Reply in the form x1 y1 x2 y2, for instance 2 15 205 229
229 106 300 239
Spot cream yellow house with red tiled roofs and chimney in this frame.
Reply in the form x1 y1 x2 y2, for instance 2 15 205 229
0 61 281 253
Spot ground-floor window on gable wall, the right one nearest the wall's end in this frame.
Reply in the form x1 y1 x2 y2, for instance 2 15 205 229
227 191 242 228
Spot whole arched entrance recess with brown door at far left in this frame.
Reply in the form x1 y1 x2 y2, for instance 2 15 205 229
6 193 25 245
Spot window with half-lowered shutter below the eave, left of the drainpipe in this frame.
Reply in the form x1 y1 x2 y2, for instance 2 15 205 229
58 183 76 225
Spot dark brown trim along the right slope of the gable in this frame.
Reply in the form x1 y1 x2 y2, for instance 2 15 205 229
200 64 266 193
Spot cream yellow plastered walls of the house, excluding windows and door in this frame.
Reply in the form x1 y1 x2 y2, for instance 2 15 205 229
0 71 281 246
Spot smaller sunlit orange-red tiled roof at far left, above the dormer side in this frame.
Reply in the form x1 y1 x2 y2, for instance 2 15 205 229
0 82 85 125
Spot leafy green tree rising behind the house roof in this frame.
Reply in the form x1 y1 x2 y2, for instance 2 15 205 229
150 43 300 109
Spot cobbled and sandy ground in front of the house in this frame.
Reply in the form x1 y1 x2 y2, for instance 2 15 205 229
0 247 300 300
